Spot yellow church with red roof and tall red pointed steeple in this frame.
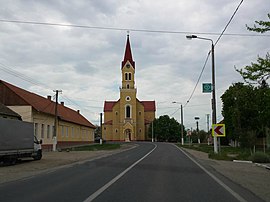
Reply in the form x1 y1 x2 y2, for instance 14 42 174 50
102 35 156 142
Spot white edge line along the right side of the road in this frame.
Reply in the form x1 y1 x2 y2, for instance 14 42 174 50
174 144 247 202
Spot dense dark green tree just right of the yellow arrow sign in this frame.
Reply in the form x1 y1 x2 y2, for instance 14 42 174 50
221 83 260 147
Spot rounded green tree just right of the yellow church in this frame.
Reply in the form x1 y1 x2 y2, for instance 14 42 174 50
148 115 185 142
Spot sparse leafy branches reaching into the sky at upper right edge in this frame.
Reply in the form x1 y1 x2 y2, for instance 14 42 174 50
236 13 270 86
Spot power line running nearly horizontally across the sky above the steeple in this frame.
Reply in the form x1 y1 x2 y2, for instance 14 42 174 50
0 19 270 37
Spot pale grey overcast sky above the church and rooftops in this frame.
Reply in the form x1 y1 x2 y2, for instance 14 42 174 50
0 0 270 130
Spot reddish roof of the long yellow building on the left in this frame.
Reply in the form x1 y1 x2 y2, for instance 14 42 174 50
0 80 96 128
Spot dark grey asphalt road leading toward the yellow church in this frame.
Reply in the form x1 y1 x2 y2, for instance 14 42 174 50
0 143 260 202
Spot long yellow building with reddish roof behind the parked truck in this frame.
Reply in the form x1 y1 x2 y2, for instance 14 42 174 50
0 80 95 150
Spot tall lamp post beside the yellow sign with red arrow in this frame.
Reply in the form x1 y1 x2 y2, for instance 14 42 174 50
186 35 218 153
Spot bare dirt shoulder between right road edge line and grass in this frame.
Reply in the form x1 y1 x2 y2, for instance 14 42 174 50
182 148 270 201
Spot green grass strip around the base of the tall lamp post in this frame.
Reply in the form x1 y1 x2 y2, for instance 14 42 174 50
177 144 270 161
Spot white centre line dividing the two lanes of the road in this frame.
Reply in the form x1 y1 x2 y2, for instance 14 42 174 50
84 144 157 202
